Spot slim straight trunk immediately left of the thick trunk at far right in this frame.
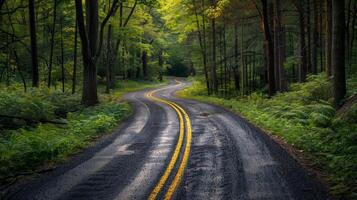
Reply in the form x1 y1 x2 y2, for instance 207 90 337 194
325 0 332 77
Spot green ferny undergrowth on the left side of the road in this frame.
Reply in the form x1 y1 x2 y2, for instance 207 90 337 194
0 81 164 183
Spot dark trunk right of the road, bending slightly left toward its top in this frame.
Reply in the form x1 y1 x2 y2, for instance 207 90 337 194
261 0 276 96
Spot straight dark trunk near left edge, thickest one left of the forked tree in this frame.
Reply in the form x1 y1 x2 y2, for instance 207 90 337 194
28 0 39 87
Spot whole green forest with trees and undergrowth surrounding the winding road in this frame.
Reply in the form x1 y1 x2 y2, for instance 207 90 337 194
0 0 357 199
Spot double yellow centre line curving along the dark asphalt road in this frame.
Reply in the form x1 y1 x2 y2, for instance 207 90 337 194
146 81 192 200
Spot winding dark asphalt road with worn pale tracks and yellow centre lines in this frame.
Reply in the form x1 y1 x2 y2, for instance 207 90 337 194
7 81 327 200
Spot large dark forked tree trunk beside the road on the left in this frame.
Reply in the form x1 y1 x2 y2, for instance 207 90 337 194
75 0 98 106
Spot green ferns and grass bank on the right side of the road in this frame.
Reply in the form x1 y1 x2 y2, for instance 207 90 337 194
179 75 357 199
